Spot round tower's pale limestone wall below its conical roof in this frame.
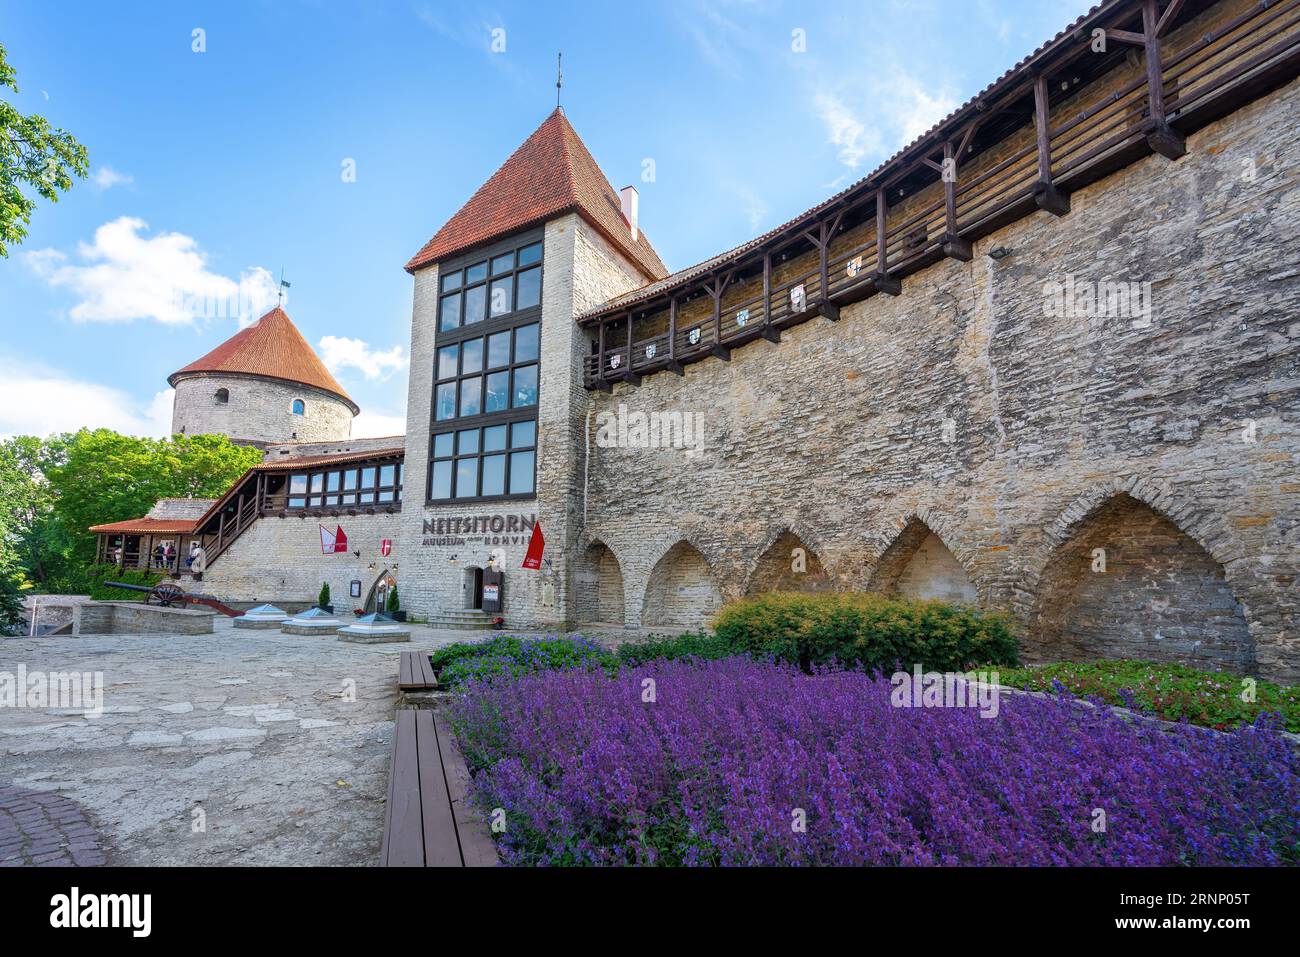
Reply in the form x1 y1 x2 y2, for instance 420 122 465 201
172 373 352 443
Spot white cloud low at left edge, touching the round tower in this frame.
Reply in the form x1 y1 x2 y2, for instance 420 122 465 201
0 360 174 437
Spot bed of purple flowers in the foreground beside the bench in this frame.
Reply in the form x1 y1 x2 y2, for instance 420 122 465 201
454 658 1300 865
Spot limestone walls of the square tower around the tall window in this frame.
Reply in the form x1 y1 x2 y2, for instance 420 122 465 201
400 215 644 629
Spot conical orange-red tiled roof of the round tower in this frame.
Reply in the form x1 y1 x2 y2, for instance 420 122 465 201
166 306 361 415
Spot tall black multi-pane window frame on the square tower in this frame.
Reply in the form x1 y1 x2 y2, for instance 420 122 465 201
425 229 546 507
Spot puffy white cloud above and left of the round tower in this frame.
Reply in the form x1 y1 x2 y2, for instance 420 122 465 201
23 216 277 325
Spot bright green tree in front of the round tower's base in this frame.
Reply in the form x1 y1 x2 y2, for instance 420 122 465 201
42 429 261 566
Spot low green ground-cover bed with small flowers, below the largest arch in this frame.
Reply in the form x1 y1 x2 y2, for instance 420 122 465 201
998 658 1300 732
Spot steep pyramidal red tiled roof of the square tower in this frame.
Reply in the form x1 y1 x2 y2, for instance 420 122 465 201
406 108 668 280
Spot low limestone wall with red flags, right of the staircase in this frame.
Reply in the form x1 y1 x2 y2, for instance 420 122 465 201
195 512 407 612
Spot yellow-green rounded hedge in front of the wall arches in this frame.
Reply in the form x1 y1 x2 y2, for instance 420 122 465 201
714 592 1019 672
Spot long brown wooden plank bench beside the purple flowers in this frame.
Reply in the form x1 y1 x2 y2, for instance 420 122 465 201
382 709 498 867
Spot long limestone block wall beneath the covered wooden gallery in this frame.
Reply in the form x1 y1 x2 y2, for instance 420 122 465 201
582 83 1300 679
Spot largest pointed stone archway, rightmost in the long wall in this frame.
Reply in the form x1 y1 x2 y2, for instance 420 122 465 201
1026 493 1255 671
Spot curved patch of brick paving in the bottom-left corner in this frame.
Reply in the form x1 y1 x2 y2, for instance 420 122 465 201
0 784 104 867
